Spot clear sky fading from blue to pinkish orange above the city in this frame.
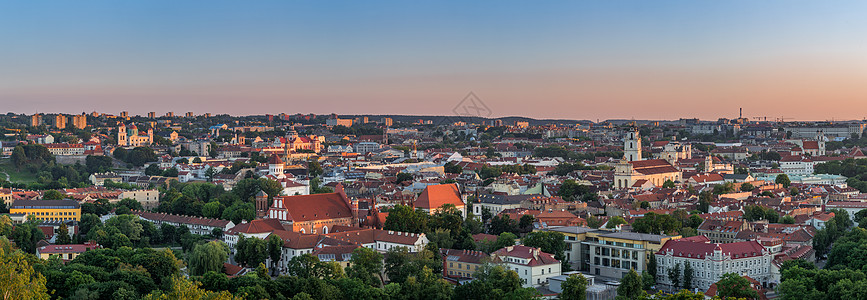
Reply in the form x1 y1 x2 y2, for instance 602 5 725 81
0 0 867 121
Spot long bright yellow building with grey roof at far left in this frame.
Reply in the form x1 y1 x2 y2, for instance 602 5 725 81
9 200 81 222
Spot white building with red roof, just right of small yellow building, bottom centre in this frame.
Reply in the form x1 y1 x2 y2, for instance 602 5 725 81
491 245 560 287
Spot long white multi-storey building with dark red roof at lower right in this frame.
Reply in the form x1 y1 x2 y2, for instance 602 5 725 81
655 237 774 290
